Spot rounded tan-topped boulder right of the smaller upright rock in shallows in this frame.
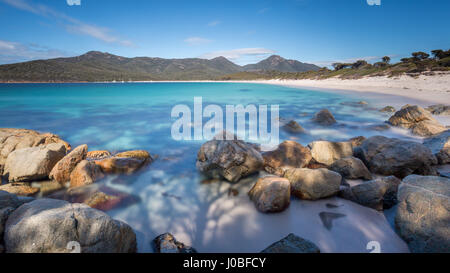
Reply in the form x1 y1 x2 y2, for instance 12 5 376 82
284 169 342 200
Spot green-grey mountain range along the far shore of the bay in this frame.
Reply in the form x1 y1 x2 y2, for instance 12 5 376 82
0 51 320 82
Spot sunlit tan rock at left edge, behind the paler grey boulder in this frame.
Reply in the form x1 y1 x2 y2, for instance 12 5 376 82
0 128 70 175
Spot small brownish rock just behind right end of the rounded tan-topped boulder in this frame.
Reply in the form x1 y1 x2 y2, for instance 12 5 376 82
330 156 372 180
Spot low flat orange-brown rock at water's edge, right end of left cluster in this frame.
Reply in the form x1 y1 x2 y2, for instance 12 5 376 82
95 157 147 174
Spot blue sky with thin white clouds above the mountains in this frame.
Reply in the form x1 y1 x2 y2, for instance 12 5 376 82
0 0 450 66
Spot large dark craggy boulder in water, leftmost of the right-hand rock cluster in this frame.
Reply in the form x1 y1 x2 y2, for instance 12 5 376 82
196 139 264 182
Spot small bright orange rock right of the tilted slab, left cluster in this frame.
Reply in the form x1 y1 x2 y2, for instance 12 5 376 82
70 160 105 188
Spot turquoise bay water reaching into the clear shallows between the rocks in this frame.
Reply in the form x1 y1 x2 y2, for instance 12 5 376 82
0 83 412 252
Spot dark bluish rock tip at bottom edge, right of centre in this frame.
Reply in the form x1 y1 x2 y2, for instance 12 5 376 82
261 233 320 253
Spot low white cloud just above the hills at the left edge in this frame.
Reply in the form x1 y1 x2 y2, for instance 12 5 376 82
0 40 73 64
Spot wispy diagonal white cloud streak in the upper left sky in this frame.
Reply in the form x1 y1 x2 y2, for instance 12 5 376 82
0 0 133 46
